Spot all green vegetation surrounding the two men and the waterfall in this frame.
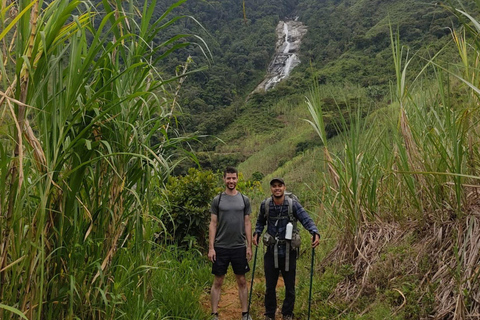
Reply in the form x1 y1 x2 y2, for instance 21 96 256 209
0 0 480 320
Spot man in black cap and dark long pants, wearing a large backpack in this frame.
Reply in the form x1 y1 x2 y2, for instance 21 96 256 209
253 178 320 320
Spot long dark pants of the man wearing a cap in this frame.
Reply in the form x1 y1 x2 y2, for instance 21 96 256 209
264 247 297 318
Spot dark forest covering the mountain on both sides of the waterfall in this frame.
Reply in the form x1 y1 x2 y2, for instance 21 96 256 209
150 0 468 173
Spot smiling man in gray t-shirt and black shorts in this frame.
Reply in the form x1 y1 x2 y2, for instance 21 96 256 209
208 167 252 320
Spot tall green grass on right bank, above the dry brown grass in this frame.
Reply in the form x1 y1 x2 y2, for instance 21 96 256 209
307 2 480 252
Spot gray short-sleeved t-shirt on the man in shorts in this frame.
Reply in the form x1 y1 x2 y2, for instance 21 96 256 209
210 192 252 249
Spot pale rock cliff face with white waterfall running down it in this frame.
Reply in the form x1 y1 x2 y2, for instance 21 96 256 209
255 20 307 92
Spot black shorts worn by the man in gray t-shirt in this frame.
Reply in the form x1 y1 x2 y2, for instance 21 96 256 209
212 247 250 276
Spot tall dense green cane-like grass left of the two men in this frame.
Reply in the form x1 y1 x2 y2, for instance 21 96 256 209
0 0 209 319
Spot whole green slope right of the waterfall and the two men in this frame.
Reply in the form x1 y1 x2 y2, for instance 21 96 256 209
174 1 480 319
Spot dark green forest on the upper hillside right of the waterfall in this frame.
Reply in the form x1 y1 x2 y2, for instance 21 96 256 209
298 0 456 83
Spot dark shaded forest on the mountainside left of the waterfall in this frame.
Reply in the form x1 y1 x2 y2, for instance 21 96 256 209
160 0 296 134
